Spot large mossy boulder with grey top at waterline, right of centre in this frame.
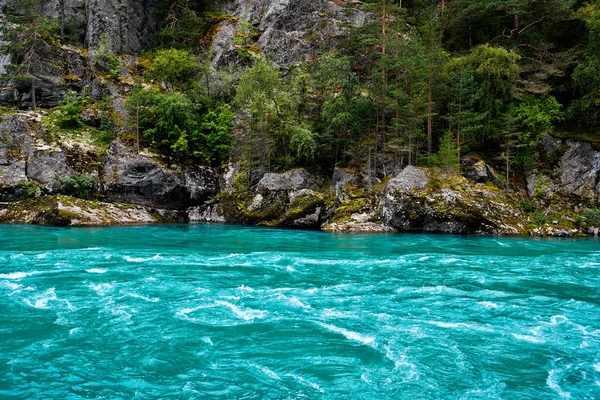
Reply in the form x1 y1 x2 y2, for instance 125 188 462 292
381 167 527 235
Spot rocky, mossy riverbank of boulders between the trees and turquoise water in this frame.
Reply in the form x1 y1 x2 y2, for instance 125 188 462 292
0 112 600 236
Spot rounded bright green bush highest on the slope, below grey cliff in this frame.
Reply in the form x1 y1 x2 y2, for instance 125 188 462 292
146 49 201 91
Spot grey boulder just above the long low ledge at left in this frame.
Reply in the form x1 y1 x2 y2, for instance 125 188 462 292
103 140 218 209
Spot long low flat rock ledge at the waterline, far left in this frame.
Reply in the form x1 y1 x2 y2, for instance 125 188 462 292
0 196 178 226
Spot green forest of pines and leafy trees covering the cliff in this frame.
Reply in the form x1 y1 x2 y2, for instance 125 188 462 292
1 0 600 182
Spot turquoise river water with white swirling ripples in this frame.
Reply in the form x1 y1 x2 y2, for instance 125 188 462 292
0 225 600 400
